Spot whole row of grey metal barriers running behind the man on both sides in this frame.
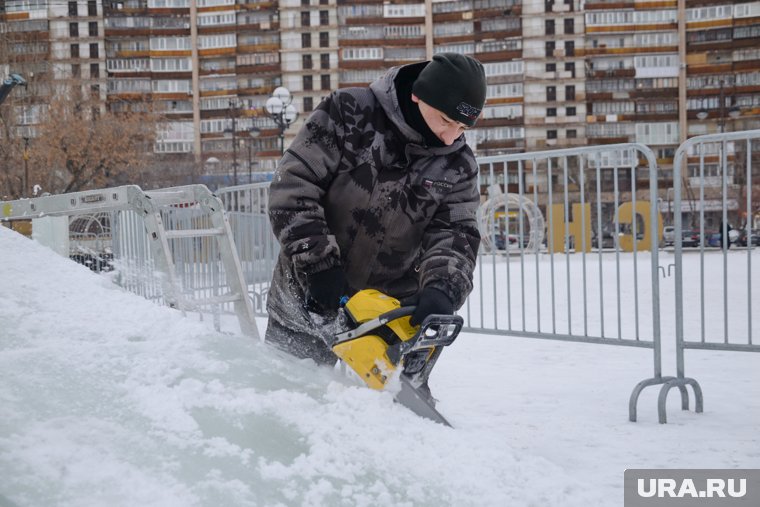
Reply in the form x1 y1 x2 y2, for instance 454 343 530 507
7 135 760 423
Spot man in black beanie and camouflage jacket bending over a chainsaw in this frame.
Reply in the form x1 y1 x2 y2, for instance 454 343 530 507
266 53 486 364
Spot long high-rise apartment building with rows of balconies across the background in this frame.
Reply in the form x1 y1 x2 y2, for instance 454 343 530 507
0 0 760 194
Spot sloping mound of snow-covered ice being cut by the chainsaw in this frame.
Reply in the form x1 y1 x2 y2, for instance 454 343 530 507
0 227 604 507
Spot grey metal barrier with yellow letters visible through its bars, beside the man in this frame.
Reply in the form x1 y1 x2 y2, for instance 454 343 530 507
476 144 685 421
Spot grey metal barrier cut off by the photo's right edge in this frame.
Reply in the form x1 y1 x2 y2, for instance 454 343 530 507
658 130 760 423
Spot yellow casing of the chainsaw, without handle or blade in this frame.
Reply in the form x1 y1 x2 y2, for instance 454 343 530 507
333 289 419 390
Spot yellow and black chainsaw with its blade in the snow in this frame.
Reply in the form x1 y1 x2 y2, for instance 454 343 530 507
331 289 463 426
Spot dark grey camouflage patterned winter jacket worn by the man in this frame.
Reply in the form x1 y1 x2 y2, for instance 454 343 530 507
267 61 480 334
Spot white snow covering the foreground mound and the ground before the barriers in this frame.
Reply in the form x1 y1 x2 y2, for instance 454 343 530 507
0 227 760 507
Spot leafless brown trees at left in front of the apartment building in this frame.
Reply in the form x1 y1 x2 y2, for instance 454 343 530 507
0 25 160 199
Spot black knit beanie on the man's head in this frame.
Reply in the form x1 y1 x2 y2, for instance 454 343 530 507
412 53 486 127
